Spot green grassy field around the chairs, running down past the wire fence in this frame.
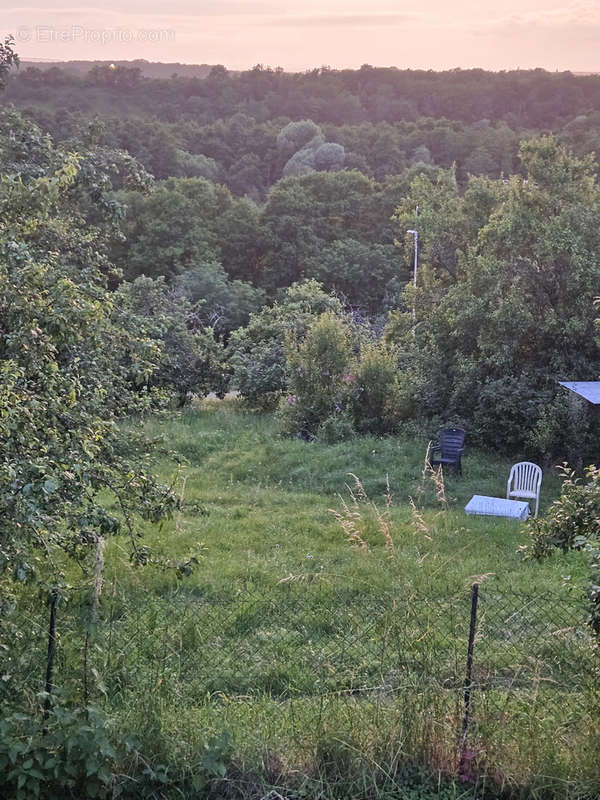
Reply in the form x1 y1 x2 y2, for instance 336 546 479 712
18 403 600 800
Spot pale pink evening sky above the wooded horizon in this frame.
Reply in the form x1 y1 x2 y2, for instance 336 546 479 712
0 0 600 72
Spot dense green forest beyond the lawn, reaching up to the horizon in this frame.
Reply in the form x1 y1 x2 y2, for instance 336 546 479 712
1 54 600 460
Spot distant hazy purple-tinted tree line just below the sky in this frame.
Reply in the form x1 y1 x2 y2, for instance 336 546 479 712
9 64 600 128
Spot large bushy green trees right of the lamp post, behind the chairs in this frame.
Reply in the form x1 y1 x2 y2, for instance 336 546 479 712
388 137 600 458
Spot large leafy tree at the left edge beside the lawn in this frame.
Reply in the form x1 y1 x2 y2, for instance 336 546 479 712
0 158 172 580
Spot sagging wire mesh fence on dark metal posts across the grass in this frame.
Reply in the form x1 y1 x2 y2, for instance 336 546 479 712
11 582 600 787
